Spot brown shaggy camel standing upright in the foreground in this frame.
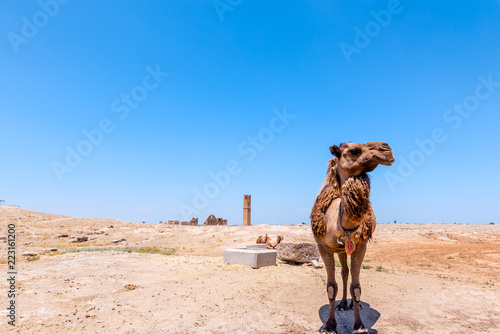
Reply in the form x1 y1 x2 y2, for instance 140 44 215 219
311 142 394 334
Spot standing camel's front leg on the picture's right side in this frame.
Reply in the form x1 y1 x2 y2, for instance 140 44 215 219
350 243 368 334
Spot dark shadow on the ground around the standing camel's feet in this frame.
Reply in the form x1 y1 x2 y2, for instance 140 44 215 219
318 300 380 334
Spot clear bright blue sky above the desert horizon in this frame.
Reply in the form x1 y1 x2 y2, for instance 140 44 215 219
0 0 500 225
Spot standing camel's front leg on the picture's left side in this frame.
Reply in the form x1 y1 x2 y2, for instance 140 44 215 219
318 243 338 333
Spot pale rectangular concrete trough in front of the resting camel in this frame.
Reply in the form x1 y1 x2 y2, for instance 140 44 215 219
224 244 277 269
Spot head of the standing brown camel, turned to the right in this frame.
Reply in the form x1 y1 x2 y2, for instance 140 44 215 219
330 142 394 177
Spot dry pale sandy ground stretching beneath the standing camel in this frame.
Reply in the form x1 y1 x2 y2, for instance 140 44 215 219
0 206 500 333
